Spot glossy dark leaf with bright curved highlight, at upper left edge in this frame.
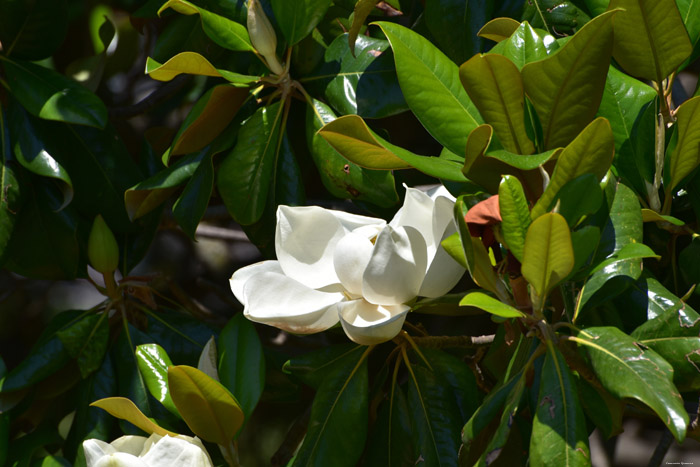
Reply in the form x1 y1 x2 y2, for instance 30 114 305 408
2 59 107 128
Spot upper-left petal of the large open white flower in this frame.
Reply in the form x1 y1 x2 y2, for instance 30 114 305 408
275 206 384 289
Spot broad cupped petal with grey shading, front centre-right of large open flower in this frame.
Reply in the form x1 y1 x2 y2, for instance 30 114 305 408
362 226 428 305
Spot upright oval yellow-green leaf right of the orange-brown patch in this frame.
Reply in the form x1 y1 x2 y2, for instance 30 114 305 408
522 213 574 302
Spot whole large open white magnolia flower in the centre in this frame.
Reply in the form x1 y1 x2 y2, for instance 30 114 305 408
231 186 464 345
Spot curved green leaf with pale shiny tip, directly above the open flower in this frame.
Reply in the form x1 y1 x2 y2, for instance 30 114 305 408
306 99 399 207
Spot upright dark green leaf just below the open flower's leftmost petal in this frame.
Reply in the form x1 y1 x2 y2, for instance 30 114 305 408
218 313 265 418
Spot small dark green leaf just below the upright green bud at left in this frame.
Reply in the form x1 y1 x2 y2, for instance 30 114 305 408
56 314 109 378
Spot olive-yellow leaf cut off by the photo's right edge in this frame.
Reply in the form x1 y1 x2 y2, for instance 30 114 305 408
667 96 700 195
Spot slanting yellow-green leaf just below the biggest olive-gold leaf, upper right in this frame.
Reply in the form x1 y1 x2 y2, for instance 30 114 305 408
531 117 615 219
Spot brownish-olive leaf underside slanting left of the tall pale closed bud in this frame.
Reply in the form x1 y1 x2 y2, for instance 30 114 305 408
170 84 249 156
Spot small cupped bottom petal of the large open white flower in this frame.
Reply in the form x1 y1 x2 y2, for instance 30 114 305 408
338 300 410 345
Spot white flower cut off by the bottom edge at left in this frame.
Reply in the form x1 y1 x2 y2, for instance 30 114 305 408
83 433 213 467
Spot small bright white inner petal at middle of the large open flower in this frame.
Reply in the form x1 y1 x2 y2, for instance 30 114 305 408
333 233 374 297
